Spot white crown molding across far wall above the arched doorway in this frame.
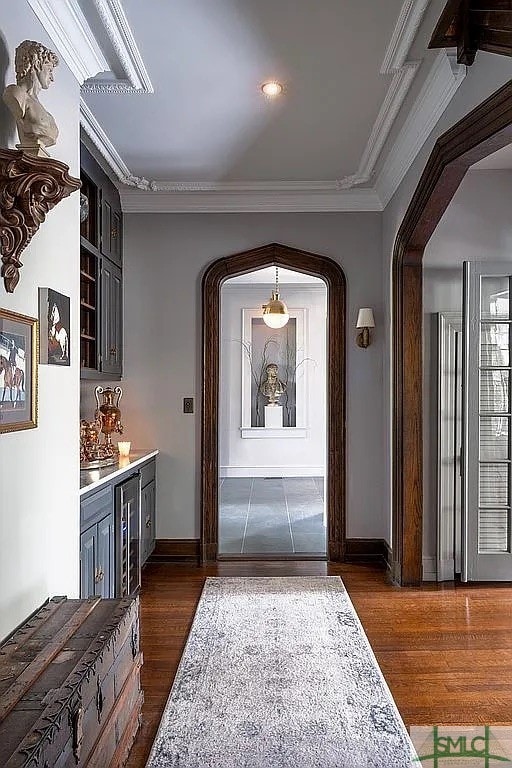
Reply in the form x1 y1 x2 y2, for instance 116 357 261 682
120 189 382 213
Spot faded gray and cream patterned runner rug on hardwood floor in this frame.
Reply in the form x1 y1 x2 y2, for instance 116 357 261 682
147 576 418 768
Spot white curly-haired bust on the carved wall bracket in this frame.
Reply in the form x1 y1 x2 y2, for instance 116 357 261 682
3 40 59 157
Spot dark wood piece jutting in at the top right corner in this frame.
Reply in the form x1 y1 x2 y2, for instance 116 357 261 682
429 0 512 66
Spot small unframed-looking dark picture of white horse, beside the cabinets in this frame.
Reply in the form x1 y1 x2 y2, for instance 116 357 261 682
39 288 70 365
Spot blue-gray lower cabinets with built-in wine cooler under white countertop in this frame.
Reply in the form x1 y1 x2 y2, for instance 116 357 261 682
80 459 156 598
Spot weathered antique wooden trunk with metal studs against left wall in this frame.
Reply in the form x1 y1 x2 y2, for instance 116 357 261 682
0 598 143 768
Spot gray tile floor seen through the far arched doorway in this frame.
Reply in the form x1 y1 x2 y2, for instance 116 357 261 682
219 477 326 555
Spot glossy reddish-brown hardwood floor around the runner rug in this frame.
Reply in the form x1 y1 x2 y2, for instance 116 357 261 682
127 561 512 768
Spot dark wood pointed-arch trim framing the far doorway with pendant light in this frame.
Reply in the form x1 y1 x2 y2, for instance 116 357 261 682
201 243 346 562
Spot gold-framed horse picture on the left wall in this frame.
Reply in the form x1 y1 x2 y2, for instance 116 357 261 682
0 309 38 432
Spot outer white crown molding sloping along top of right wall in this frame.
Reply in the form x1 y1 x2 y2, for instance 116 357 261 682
374 51 466 208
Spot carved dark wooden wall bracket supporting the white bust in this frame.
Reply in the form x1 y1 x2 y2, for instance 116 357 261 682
0 149 81 293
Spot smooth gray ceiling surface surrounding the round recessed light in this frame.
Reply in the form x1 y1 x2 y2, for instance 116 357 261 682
85 0 403 182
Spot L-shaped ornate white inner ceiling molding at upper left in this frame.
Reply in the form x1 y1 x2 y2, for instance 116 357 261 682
83 0 155 93
